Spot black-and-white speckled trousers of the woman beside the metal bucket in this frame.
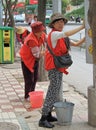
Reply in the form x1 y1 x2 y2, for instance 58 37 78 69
42 69 63 115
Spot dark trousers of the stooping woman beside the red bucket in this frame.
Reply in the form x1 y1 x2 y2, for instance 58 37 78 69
21 61 39 98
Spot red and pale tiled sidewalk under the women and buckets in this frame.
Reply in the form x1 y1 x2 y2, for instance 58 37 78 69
0 58 96 130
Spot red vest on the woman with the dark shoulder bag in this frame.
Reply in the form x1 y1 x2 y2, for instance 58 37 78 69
45 29 68 74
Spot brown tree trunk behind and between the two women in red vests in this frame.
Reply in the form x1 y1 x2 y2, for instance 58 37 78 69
38 0 48 81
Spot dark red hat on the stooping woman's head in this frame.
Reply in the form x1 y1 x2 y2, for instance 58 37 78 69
31 21 45 33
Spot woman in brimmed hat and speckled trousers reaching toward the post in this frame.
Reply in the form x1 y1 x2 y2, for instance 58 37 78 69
39 13 84 128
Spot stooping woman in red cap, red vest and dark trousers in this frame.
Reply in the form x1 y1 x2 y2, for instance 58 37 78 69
20 21 45 99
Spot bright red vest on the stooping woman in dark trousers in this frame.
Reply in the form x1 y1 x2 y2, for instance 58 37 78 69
20 33 45 72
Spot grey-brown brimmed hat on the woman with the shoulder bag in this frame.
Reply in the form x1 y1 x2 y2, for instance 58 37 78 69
49 13 68 28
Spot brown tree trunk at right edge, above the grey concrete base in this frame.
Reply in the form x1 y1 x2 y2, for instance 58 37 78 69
88 0 96 88
